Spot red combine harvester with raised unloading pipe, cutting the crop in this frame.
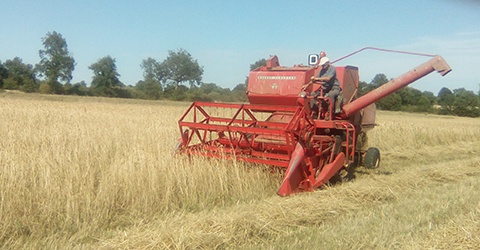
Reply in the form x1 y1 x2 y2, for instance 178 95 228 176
178 48 451 196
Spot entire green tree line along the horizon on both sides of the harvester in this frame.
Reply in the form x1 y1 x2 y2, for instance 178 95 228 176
0 31 480 117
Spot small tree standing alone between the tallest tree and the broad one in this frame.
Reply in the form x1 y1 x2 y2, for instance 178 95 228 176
88 56 123 91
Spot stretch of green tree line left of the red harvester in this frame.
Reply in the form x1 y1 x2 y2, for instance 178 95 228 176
0 31 246 102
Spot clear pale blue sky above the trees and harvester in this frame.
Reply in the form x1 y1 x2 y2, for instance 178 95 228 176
0 0 480 94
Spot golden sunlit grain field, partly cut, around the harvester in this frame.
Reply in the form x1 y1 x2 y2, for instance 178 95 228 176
0 93 480 249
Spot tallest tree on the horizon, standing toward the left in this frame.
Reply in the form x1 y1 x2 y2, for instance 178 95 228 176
37 31 75 92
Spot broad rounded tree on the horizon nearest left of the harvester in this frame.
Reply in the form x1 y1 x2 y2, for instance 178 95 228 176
157 49 203 89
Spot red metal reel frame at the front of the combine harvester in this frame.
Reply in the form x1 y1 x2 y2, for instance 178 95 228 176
179 102 313 167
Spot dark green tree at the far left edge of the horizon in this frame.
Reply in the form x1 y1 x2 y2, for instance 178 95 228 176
4 57 36 92
